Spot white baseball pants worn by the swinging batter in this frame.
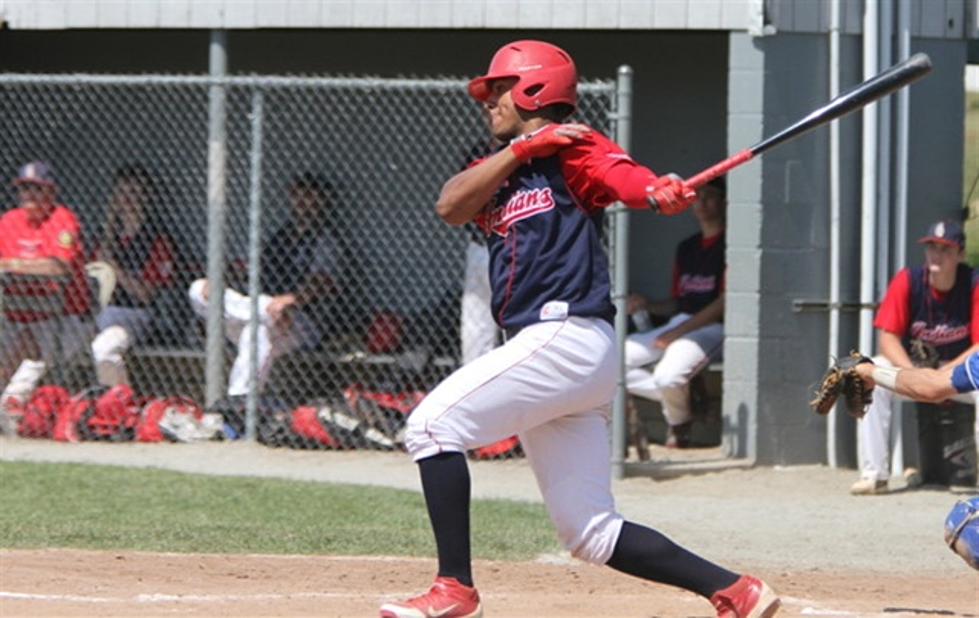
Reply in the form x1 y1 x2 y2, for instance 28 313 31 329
406 317 622 564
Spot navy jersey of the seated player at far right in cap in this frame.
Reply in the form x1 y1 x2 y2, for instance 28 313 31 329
903 264 975 361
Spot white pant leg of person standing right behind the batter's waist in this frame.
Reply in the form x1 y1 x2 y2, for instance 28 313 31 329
459 242 499 365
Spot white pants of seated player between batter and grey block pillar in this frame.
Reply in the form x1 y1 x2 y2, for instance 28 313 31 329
625 313 724 425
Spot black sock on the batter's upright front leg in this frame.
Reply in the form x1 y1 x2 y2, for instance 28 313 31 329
418 453 473 586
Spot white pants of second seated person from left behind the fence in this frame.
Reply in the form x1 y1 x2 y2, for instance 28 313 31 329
92 305 153 386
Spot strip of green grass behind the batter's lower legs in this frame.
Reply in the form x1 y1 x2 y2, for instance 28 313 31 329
0 463 558 560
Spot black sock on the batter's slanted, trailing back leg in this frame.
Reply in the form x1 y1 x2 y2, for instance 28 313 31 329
606 521 739 598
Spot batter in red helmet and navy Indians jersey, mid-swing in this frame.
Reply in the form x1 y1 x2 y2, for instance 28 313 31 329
381 41 779 618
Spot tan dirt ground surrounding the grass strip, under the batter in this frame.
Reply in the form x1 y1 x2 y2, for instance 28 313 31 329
0 439 979 618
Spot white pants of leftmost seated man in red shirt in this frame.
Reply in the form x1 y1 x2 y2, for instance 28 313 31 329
0 315 93 402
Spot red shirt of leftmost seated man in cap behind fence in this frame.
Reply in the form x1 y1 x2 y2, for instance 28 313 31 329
0 204 89 322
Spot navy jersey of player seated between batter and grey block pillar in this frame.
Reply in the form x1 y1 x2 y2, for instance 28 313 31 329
673 232 725 315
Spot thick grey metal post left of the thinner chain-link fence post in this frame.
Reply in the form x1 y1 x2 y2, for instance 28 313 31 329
204 30 228 405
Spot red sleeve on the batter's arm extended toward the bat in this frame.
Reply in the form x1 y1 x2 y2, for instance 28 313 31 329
560 131 656 208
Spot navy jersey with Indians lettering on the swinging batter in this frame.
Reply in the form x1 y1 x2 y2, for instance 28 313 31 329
477 156 615 329
